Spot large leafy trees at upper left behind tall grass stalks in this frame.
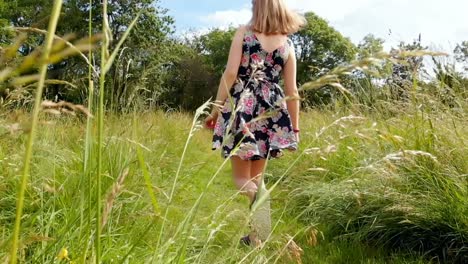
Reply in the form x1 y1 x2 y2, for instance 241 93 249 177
0 0 173 109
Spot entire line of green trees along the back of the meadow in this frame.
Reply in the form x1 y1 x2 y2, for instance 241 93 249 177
0 0 468 110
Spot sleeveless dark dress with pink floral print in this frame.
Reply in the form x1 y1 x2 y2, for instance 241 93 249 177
213 31 297 160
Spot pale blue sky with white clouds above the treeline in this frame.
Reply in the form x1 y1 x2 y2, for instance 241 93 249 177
160 0 468 52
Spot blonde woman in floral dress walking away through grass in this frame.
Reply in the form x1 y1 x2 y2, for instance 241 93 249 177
205 0 305 244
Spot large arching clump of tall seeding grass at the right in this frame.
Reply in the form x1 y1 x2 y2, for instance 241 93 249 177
288 94 468 263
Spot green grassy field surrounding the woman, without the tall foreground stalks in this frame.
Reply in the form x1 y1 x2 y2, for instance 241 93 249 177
0 100 468 263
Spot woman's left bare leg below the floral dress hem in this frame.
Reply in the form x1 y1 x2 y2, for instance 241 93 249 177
231 156 257 202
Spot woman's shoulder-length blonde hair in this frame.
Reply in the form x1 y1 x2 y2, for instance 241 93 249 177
249 0 306 35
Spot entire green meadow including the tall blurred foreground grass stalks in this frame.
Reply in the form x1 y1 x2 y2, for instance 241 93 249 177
0 0 468 264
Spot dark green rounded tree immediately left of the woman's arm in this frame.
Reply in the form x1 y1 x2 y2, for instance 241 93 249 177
159 28 236 110
